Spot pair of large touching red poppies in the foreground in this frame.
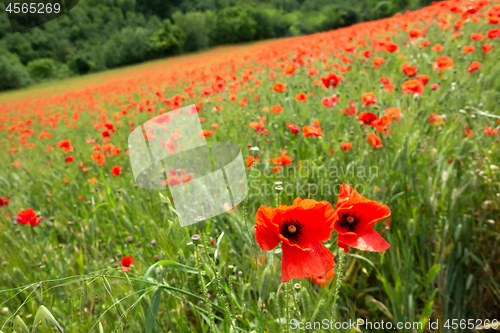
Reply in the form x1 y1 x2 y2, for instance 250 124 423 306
255 184 391 282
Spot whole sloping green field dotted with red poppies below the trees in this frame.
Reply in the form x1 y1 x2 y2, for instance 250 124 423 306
0 0 500 333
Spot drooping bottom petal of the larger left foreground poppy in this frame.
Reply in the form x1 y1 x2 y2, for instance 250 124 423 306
281 242 335 282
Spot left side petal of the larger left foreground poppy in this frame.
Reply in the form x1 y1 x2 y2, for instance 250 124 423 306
255 206 280 251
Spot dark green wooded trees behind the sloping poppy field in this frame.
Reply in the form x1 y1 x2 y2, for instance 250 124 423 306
0 0 431 91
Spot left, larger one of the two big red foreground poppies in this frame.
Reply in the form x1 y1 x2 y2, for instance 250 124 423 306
255 198 335 282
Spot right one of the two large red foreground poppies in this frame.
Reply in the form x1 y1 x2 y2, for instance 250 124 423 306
333 184 391 252
